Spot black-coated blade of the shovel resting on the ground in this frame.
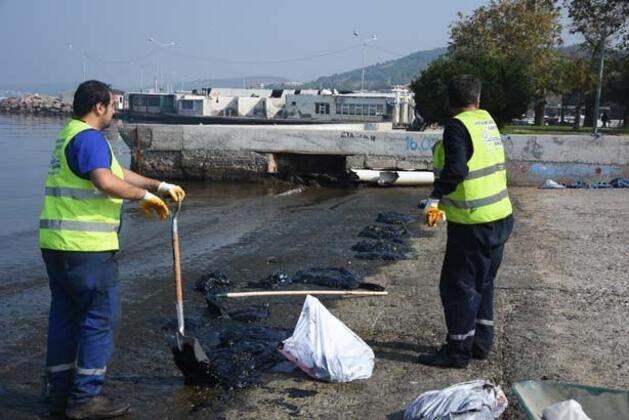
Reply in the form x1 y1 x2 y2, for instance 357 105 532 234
167 332 218 385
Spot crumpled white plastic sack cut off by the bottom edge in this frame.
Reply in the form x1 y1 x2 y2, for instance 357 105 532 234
404 379 508 420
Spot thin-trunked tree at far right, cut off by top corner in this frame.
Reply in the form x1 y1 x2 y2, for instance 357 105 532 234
564 0 629 131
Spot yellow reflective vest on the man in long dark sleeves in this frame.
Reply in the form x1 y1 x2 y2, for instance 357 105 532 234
433 109 512 224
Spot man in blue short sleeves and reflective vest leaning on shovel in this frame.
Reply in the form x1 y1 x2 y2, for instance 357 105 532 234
39 80 185 419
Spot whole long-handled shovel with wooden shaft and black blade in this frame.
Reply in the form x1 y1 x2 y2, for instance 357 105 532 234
167 201 216 384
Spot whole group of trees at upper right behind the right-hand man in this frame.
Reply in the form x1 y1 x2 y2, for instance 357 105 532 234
411 0 629 128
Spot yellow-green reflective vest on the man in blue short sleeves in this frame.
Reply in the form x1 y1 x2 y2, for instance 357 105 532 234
39 119 124 252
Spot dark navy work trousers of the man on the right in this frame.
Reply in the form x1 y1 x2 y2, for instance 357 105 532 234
439 215 513 360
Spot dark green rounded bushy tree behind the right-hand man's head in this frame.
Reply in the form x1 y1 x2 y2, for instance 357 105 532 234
411 54 531 126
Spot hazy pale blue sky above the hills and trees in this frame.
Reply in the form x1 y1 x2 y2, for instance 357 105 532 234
0 0 580 87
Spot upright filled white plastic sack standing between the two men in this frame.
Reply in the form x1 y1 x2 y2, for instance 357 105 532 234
279 296 375 382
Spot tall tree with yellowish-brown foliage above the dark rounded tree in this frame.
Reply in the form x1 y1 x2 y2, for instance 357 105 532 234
449 0 561 125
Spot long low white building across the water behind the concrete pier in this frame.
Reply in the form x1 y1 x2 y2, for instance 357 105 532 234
129 87 415 127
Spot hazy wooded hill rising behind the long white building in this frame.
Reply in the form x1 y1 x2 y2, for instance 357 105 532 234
305 48 446 90
